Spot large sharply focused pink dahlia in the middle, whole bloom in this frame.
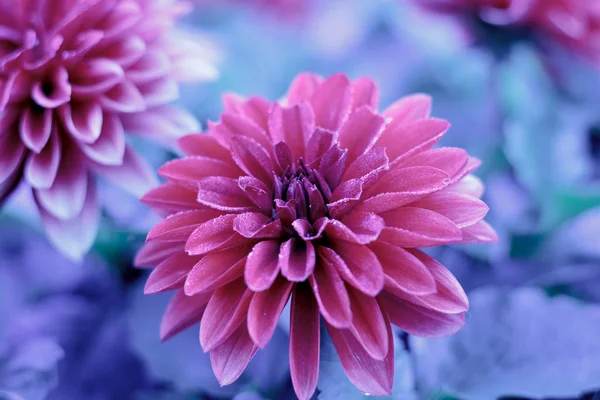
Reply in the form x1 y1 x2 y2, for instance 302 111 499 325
136 74 496 399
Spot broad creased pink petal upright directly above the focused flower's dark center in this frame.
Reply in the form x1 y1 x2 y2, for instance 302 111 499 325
269 103 315 160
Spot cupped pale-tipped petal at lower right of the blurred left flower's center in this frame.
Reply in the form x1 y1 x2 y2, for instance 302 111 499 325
80 114 125 165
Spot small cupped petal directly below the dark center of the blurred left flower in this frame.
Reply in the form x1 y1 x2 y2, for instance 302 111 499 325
19 106 52 153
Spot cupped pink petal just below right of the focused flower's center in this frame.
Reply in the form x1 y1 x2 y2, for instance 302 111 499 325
317 244 383 296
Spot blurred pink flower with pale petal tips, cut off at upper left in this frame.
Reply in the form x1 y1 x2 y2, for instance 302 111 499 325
0 0 214 258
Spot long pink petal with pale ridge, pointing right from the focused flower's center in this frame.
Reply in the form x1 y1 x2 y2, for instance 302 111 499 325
358 167 448 213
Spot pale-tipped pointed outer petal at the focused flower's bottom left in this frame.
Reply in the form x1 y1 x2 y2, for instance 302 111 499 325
211 324 258 386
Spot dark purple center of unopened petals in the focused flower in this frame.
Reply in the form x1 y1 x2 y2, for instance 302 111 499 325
274 159 331 226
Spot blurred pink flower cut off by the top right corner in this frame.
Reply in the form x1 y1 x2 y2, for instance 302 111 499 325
414 0 600 61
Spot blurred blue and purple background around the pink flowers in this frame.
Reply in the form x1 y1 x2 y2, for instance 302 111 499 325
0 0 600 400
